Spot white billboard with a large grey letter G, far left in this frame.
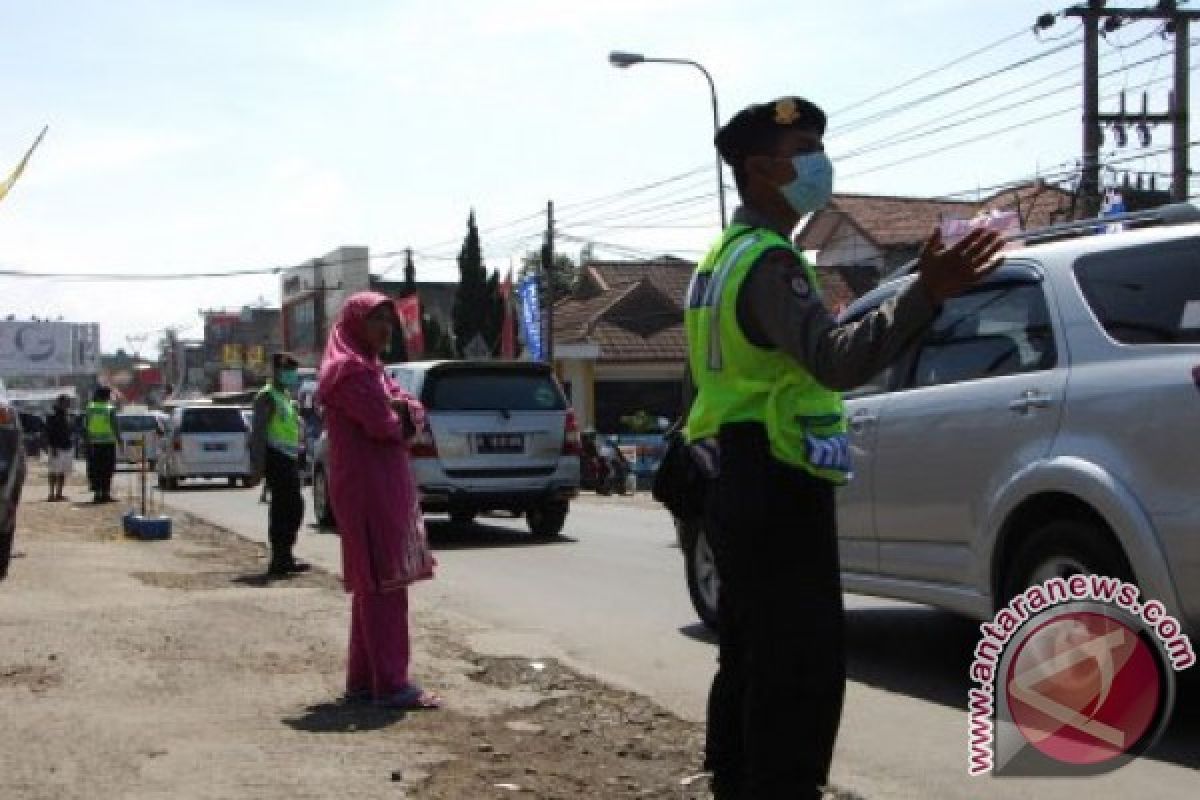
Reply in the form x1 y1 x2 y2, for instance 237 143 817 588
0 319 100 377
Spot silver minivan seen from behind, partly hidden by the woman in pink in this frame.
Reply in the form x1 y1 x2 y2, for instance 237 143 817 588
312 361 581 539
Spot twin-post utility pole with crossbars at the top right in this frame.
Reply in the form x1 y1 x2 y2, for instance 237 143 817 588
1065 0 1200 216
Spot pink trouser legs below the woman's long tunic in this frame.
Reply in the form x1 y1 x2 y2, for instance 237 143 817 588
346 589 409 698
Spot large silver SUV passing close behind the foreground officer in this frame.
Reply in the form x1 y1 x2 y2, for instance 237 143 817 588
678 205 1200 631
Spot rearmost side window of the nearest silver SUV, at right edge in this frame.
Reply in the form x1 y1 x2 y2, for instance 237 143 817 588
1075 239 1200 344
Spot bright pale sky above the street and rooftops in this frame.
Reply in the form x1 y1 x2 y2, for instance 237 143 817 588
0 0 1200 353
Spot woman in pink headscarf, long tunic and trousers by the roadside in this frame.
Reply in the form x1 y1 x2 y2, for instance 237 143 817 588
317 291 440 709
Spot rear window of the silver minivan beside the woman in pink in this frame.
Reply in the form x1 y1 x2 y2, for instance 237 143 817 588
421 369 566 411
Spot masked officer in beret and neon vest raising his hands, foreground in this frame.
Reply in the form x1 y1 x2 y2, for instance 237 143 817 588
685 97 1001 800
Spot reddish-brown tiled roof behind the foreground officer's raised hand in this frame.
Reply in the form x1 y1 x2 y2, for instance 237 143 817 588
796 182 1074 249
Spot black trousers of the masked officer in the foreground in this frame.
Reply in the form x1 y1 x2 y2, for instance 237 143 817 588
706 423 846 800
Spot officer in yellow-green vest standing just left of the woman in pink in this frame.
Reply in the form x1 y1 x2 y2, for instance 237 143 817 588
250 353 310 577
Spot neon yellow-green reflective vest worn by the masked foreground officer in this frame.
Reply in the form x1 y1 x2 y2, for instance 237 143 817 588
684 225 850 483
